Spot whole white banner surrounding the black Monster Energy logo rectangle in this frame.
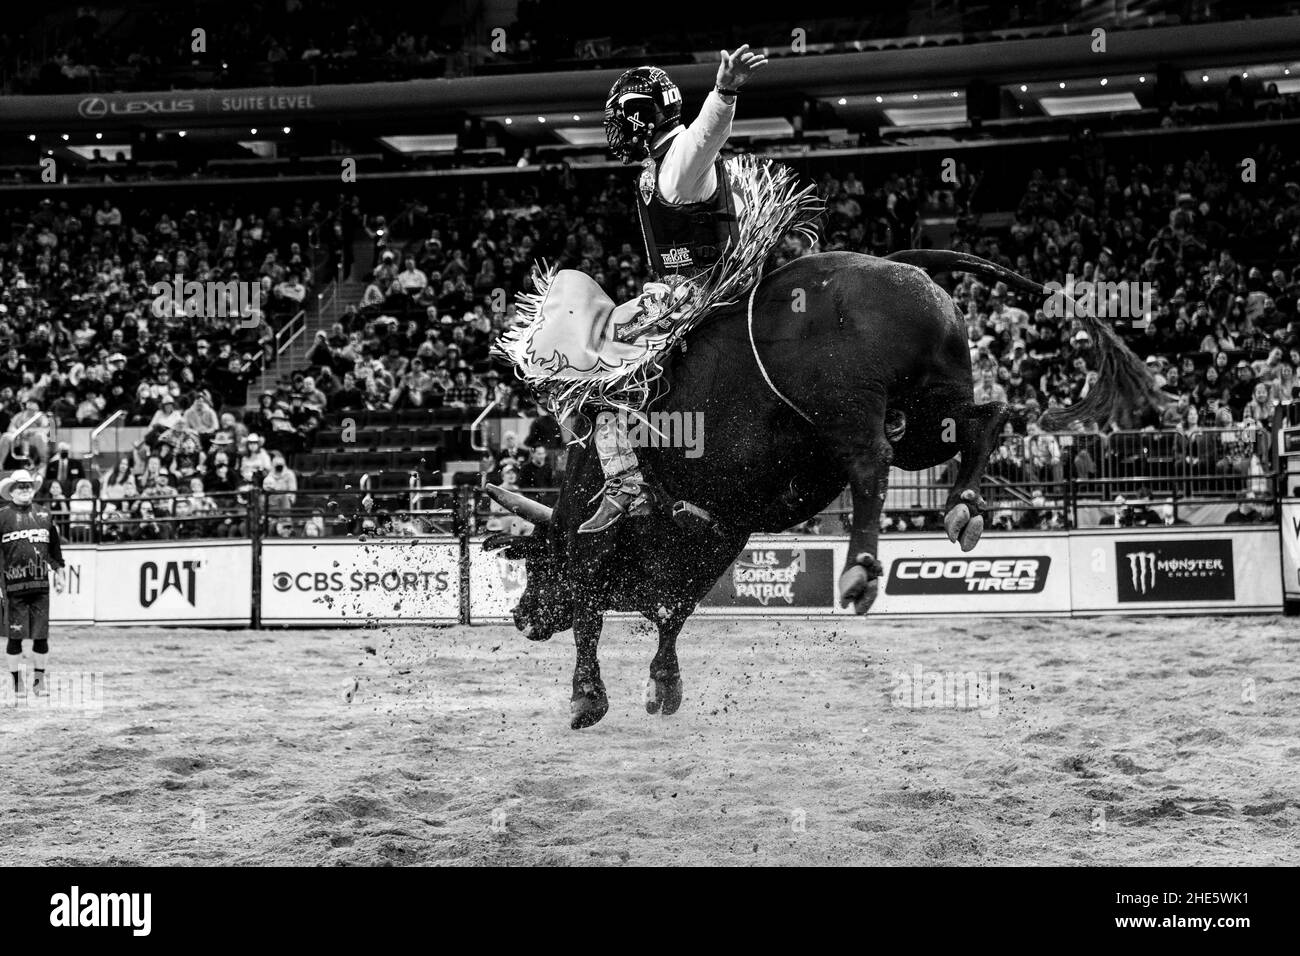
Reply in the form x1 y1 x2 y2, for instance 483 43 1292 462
1070 524 1282 614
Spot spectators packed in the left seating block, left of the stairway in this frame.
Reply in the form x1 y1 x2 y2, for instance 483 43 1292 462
0 191 366 540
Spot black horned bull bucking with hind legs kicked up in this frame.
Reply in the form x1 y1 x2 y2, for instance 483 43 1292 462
485 250 1158 728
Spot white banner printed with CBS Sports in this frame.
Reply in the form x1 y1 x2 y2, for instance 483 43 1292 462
261 537 460 626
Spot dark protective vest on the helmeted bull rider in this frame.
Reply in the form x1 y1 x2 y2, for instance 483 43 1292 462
637 159 740 278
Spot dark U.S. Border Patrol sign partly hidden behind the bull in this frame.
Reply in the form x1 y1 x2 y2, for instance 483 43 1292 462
699 548 835 609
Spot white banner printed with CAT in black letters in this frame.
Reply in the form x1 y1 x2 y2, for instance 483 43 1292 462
86 541 252 624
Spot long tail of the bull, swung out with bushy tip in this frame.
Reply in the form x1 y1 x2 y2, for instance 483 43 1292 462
885 248 1167 428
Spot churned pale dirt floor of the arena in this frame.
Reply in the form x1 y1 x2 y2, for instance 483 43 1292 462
0 618 1300 866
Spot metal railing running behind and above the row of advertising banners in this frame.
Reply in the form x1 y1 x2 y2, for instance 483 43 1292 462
27 419 1281 544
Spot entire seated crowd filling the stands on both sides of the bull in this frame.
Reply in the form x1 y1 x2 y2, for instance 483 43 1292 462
0 87 1300 537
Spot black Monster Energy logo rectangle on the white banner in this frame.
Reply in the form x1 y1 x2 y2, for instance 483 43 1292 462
1115 538 1236 604
